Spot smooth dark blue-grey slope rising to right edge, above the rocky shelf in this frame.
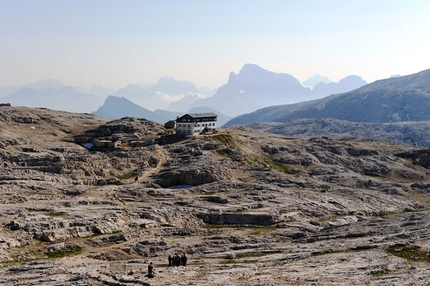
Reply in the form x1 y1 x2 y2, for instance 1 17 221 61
226 70 430 126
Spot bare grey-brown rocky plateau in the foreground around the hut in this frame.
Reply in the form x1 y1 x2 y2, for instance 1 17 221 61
0 106 430 286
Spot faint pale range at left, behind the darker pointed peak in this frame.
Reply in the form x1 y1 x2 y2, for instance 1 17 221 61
0 77 213 115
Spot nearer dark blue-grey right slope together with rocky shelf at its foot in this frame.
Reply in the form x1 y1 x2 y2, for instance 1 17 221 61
225 70 430 146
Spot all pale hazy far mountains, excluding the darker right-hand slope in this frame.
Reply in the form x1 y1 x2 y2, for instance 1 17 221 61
0 64 366 123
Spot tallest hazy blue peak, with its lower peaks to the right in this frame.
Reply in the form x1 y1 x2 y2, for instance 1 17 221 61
191 64 366 116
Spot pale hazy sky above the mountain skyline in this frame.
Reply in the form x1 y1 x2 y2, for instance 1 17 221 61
0 0 430 88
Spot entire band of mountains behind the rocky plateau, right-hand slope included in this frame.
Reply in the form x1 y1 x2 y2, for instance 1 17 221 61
0 64 430 146
